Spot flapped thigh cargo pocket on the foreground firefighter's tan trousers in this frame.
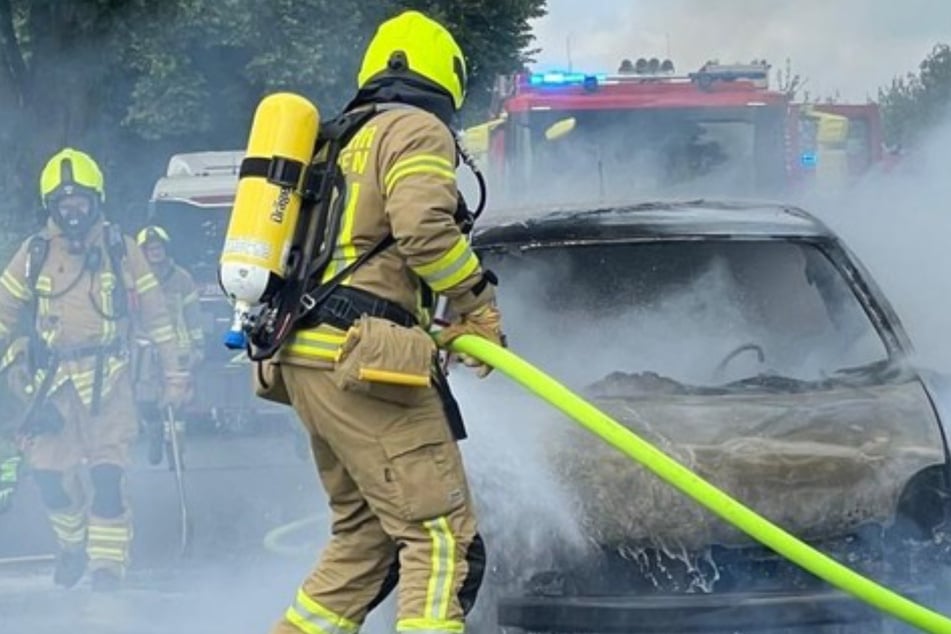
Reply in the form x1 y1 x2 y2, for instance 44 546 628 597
380 428 466 522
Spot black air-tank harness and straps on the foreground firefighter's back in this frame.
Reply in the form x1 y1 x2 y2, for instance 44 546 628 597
241 104 486 361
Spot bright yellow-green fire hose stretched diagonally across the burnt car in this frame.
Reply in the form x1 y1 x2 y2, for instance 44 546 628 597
451 336 951 634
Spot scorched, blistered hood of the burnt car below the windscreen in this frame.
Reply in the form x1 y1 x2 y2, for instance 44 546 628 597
549 375 944 550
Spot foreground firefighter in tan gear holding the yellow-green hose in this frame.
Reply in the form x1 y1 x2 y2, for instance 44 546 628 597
272 11 502 634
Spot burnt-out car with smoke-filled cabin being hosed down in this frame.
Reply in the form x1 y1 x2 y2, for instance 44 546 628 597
474 200 951 632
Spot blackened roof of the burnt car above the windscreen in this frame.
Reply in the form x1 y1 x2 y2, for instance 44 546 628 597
473 200 835 246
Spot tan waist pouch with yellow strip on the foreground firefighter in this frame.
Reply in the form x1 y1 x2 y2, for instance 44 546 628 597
334 316 436 407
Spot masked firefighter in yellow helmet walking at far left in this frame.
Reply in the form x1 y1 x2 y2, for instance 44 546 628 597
0 148 189 591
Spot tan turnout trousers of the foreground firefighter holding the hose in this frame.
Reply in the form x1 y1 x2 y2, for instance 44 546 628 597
271 365 485 634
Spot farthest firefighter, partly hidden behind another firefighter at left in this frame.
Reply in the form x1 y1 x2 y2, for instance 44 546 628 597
133 225 205 466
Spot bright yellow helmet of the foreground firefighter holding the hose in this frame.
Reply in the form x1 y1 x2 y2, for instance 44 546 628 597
357 11 467 110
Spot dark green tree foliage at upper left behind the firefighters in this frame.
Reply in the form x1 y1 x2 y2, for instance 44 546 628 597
0 0 546 244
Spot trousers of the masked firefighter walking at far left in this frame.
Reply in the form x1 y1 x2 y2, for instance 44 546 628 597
26 370 138 575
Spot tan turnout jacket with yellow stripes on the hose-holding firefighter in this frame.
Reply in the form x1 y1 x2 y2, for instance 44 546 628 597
279 106 492 366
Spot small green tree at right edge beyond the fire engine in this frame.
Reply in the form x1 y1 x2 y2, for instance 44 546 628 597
878 44 951 146
